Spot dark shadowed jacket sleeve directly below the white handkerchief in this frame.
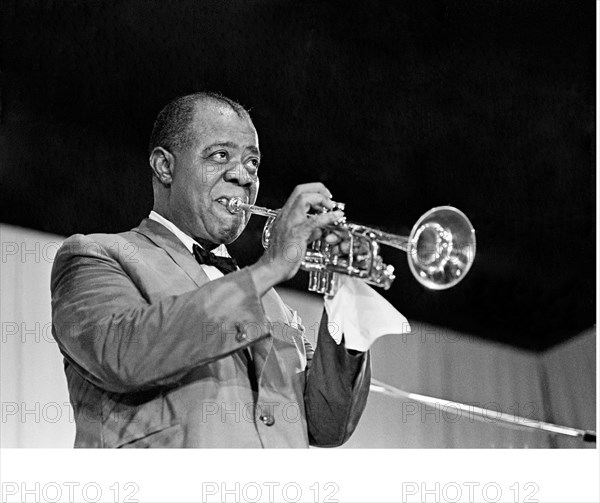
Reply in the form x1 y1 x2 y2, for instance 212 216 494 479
304 310 371 447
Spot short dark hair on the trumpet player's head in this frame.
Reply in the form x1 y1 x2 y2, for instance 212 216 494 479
148 91 250 154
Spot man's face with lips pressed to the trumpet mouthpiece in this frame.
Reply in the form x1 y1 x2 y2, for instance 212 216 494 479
170 102 260 244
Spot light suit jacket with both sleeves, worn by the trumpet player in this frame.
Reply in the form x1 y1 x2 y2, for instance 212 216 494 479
51 219 370 448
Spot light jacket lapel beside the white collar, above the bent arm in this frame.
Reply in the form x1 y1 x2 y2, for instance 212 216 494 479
132 218 209 286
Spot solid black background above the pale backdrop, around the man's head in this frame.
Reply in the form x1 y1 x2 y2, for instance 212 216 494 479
0 0 596 350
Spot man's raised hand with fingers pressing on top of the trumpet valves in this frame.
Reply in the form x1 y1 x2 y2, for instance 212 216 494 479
250 182 344 296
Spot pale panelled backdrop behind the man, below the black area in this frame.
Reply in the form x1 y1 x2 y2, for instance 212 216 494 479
0 224 596 448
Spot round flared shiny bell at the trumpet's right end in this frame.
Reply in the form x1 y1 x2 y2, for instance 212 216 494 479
406 206 476 290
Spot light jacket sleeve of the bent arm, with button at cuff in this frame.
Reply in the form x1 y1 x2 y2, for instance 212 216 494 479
51 235 270 392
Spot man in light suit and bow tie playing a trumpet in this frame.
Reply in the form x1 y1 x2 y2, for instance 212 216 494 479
51 93 370 448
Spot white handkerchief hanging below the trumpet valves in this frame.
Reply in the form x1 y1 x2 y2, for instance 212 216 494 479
325 275 410 351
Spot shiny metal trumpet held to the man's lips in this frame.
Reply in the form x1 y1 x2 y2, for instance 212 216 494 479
227 197 476 297
